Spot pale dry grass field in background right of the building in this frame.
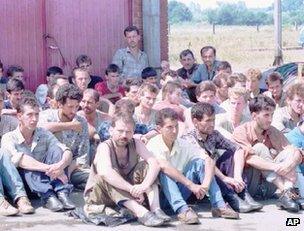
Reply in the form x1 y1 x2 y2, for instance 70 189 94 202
169 24 304 71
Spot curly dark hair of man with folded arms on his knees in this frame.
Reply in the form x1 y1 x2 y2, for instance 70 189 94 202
55 84 82 105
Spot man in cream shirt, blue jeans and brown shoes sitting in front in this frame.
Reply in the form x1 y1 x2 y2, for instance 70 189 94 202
147 108 239 224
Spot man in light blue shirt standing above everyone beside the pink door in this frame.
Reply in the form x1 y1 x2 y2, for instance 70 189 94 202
112 26 149 80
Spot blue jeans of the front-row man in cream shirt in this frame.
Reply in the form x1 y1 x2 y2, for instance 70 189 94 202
159 159 225 212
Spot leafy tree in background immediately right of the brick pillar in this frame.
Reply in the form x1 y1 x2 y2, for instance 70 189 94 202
168 1 193 24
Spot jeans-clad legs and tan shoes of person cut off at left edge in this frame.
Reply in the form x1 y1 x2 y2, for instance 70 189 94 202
0 149 35 216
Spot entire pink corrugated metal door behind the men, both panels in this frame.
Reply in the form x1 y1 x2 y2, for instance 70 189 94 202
0 0 132 90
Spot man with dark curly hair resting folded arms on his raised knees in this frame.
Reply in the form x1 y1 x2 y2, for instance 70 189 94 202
39 84 90 189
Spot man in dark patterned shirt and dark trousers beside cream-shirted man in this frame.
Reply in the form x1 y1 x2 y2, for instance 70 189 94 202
181 102 263 213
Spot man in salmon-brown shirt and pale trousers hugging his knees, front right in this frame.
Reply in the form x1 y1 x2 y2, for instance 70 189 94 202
233 95 304 212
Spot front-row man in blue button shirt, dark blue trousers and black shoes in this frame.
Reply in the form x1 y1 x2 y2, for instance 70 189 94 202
1 98 75 211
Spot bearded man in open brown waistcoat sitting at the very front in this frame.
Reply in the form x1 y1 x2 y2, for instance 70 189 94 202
84 113 170 226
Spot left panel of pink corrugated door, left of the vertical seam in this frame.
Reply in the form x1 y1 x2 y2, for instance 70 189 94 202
0 0 46 88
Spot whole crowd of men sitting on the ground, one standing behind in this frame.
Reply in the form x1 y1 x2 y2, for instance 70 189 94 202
0 26 304 226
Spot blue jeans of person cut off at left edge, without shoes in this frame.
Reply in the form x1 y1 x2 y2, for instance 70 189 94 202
0 149 26 202
